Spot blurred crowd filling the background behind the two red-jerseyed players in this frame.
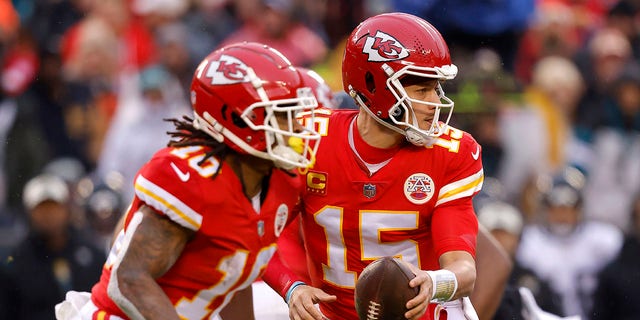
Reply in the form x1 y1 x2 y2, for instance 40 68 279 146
0 0 640 319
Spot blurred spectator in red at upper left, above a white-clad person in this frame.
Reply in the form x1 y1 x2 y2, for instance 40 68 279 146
62 0 157 169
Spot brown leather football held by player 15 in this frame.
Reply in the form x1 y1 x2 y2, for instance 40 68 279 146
354 257 420 320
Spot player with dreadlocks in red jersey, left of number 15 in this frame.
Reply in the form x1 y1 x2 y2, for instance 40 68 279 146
56 43 320 320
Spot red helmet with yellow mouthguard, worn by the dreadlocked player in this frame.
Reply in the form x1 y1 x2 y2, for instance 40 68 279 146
191 42 320 169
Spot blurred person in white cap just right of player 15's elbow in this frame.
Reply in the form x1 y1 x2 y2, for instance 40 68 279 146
478 200 562 320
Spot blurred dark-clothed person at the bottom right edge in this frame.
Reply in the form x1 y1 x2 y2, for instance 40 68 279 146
590 194 640 320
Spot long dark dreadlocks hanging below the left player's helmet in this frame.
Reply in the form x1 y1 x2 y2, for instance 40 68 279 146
164 116 233 178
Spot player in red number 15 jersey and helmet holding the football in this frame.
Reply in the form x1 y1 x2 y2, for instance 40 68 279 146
264 13 498 320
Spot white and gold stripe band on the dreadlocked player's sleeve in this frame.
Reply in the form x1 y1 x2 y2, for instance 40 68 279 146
135 175 202 230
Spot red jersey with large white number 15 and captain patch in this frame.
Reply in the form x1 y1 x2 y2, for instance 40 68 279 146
298 111 484 319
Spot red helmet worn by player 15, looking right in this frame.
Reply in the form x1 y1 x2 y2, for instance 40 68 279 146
342 13 458 145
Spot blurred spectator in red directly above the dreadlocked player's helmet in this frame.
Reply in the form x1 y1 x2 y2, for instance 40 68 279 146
220 0 327 67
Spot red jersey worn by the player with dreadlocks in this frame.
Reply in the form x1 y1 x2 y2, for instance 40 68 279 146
92 146 301 319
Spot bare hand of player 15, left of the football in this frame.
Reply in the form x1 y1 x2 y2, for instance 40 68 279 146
289 285 337 320
